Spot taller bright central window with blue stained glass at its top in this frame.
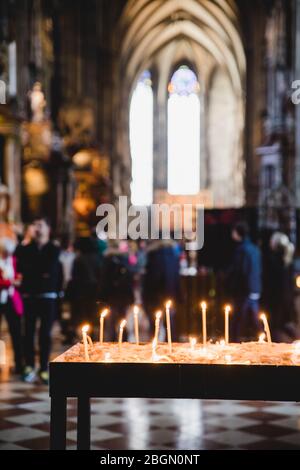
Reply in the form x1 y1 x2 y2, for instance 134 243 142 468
168 66 200 195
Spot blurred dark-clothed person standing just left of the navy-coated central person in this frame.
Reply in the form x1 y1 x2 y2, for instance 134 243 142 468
101 240 135 341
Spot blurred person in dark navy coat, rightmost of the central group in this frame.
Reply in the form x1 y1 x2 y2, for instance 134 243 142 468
142 240 180 339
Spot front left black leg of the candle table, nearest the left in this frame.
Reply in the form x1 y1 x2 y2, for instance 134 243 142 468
50 396 67 450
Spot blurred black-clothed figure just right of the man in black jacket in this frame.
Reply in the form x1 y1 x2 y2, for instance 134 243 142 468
66 238 102 330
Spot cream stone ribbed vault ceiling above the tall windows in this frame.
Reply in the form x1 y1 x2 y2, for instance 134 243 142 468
122 0 245 93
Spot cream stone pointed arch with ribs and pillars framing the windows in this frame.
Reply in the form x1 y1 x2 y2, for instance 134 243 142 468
116 0 246 205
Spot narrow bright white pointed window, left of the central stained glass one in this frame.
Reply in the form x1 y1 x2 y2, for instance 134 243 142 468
130 70 153 206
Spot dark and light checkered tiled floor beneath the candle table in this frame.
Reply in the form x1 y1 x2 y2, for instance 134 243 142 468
0 324 300 450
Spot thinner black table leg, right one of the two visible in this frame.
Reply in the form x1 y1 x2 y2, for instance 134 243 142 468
77 396 91 450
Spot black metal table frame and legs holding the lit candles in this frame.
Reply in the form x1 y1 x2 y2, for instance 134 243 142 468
50 362 300 450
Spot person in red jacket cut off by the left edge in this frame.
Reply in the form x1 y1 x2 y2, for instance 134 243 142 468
0 238 23 374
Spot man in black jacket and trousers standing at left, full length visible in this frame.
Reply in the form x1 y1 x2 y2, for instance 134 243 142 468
17 218 62 383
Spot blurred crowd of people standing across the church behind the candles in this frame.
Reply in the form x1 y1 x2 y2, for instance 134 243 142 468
0 218 297 383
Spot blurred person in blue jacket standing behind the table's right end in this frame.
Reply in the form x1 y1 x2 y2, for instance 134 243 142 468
228 222 262 342
